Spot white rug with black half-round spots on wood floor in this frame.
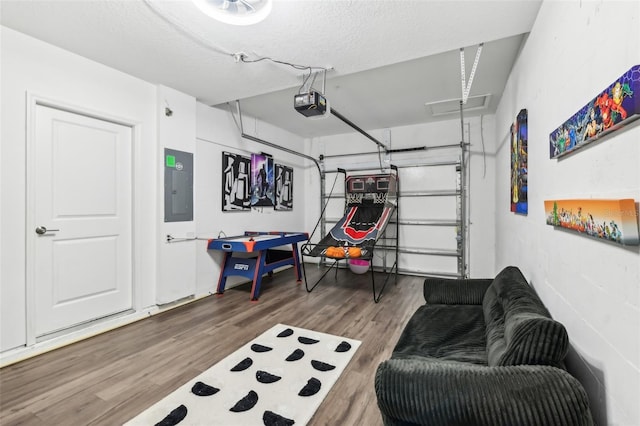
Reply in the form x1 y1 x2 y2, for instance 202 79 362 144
126 324 360 426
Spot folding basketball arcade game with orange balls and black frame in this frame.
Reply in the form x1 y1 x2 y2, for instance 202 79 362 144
301 166 398 303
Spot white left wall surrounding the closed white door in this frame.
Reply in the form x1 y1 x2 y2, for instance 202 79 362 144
0 27 157 351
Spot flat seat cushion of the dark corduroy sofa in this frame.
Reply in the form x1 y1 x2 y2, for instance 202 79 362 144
392 304 487 365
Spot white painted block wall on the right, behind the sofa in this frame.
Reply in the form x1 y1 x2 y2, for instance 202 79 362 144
495 0 640 425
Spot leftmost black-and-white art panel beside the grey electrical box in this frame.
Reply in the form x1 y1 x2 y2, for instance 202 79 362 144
222 152 251 212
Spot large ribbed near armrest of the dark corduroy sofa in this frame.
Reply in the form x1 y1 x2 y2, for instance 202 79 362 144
375 357 593 426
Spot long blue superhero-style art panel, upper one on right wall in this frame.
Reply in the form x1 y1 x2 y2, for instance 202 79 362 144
549 65 640 158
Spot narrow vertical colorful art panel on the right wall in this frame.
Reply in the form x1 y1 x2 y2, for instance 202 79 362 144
511 109 529 214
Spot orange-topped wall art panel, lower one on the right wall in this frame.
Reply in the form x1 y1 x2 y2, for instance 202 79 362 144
544 199 640 246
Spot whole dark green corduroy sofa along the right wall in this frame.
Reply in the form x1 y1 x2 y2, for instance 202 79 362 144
375 266 593 426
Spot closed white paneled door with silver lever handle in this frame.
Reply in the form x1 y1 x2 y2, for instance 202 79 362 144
29 105 133 337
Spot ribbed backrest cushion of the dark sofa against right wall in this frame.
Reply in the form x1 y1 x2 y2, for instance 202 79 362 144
483 266 569 366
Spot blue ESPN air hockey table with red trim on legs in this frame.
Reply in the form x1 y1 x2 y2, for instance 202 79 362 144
207 232 309 301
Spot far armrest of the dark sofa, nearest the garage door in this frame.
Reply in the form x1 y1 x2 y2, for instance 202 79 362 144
424 278 493 305
